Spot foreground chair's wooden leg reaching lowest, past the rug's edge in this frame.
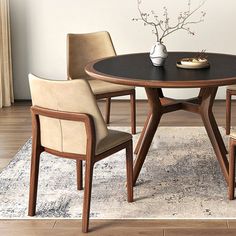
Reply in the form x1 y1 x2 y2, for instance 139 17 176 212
82 160 94 233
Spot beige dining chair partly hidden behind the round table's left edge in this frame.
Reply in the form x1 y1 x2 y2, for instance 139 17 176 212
67 31 136 134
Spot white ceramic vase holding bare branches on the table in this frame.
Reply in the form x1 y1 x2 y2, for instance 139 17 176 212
150 42 168 66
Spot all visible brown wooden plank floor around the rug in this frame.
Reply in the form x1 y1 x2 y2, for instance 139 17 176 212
0 101 236 236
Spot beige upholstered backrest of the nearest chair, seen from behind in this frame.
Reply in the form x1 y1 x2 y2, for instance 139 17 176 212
29 74 108 154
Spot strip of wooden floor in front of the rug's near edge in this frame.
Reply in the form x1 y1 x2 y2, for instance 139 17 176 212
0 220 236 236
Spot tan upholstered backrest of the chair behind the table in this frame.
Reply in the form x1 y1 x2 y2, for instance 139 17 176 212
67 31 116 79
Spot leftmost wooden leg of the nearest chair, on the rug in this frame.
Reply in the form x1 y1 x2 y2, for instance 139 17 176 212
28 143 42 216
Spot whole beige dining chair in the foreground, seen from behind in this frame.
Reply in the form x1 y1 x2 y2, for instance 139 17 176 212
28 74 133 233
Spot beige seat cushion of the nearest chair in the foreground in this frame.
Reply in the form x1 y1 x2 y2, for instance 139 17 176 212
96 129 132 155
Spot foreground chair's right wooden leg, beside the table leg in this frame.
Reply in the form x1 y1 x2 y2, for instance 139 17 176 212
126 140 133 202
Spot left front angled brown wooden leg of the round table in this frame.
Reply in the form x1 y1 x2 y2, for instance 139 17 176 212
134 88 162 185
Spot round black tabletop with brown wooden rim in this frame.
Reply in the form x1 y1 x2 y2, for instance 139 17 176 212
86 52 236 88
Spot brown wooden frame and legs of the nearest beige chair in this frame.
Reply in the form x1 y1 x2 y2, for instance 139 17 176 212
28 106 133 233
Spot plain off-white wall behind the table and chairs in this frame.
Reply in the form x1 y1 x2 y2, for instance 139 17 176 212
10 0 236 99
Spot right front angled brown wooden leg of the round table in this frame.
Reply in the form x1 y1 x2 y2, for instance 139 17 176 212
199 88 229 183
